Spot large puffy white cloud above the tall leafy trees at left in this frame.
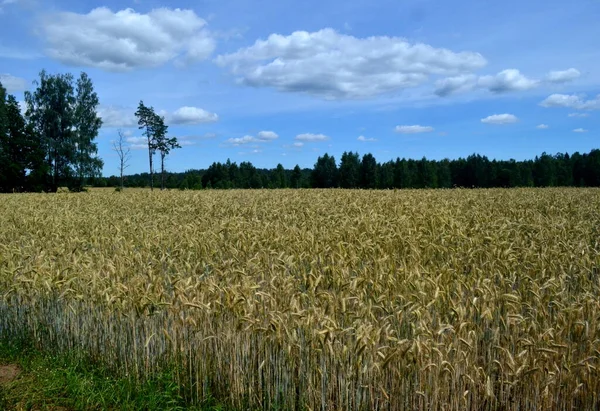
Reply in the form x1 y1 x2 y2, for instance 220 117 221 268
39 7 215 71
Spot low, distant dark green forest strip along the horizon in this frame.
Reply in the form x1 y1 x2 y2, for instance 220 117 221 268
94 149 600 189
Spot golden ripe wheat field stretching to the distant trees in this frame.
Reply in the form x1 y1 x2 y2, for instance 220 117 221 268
0 188 600 410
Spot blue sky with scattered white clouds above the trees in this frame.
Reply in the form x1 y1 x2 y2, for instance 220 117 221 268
0 0 600 175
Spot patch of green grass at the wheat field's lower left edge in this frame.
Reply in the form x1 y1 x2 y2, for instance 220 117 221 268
0 339 221 410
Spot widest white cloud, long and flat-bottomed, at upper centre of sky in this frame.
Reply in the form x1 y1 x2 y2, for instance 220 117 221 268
216 28 486 99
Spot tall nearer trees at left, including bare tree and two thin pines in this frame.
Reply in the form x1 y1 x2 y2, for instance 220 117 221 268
0 70 180 193
